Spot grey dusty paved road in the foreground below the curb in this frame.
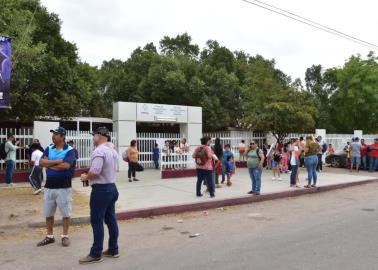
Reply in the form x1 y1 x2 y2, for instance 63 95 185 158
0 184 378 270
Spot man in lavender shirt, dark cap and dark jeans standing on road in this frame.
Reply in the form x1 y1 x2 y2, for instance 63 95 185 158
79 127 119 264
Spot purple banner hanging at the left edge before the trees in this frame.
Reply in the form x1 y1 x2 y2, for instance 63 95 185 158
0 36 12 109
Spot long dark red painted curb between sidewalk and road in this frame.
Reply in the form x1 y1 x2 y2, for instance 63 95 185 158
28 178 378 228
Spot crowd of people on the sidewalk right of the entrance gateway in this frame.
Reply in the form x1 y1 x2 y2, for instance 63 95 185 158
192 136 378 198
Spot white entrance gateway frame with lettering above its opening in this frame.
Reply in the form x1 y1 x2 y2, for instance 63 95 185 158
113 102 202 171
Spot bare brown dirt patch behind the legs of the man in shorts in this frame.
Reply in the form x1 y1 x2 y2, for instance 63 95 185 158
0 187 89 230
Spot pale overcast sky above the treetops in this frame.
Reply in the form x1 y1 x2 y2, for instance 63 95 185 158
41 0 378 80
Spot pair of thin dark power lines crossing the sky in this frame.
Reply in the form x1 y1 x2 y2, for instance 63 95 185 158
242 0 378 50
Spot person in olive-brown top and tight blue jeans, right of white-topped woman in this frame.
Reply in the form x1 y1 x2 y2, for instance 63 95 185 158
304 136 321 188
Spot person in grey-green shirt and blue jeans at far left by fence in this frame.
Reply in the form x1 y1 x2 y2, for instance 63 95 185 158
4 133 21 187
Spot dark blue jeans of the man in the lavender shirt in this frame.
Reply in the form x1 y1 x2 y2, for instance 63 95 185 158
90 184 118 258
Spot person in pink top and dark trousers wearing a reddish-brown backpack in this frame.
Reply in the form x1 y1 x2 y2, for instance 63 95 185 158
193 137 215 198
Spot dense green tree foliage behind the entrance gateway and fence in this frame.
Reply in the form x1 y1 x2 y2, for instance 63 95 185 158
0 0 378 137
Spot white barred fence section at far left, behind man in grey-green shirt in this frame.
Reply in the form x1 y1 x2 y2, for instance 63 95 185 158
0 128 33 170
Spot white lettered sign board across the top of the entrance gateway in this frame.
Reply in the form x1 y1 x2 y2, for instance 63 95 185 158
136 103 188 123
